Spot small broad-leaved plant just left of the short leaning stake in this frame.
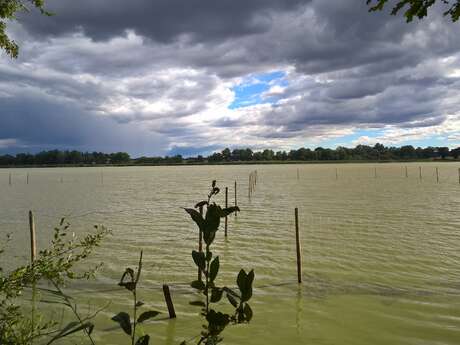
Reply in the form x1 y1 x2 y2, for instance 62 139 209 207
112 251 160 345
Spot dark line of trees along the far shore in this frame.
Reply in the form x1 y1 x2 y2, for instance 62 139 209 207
0 144 460 168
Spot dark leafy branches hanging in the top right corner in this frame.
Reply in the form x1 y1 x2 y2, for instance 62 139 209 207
366 0 460 22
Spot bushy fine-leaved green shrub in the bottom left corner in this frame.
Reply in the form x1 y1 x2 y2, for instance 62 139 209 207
0 219 109 345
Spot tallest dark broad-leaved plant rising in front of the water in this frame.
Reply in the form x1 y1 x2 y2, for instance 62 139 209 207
182 180 254 345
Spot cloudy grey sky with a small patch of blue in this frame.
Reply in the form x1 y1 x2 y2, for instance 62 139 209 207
0 0 460 156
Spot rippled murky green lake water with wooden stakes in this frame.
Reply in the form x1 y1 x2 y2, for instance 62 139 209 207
0 163 460 345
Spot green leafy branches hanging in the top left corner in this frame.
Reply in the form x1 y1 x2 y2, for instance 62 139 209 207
0 0 51 58
